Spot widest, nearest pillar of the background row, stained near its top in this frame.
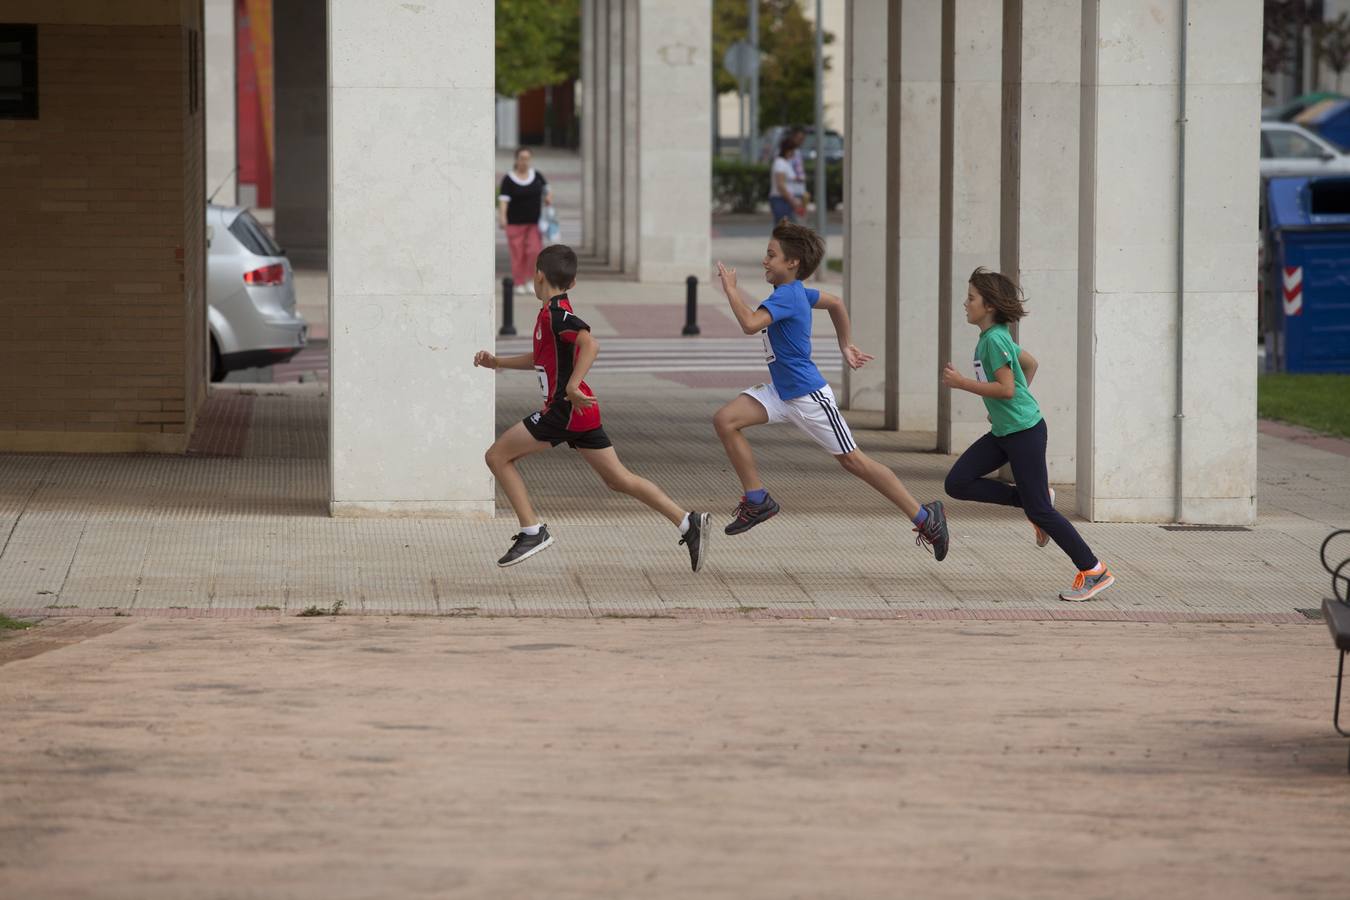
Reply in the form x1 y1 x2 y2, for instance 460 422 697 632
637 0 713 282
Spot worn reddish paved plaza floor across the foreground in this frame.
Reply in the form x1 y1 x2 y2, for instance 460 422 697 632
0 617 1350 900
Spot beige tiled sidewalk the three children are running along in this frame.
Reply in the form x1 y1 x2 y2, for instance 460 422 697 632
0 375 1350 623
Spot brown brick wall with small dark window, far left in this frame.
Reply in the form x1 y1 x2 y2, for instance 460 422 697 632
0 11 207 452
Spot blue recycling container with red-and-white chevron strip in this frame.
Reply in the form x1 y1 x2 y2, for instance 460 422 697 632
1266 175 1350 372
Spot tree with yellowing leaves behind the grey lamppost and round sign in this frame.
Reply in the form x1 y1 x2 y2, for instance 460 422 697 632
713 0 834 131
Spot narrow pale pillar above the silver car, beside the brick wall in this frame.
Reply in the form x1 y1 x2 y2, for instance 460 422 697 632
203 0 239 206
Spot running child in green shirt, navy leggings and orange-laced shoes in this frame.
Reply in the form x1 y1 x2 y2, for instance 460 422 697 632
942 267 1115 600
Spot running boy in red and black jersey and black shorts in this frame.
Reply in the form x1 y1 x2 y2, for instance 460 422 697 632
474 244 709 572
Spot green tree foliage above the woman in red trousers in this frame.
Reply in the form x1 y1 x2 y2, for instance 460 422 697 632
495 0 582 97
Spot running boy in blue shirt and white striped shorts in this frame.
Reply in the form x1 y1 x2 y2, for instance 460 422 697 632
713 220 948 560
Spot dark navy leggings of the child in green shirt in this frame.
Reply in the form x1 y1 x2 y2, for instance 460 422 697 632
946 418 1098 572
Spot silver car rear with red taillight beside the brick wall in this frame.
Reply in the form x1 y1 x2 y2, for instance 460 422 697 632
207 205 309 382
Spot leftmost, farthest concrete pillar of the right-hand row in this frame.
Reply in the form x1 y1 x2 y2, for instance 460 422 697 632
844 3 898 415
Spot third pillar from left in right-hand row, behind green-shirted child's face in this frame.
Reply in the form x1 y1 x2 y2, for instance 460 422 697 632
938 0 1003 453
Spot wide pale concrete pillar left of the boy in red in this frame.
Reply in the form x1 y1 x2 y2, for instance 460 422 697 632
329 0 495 515
